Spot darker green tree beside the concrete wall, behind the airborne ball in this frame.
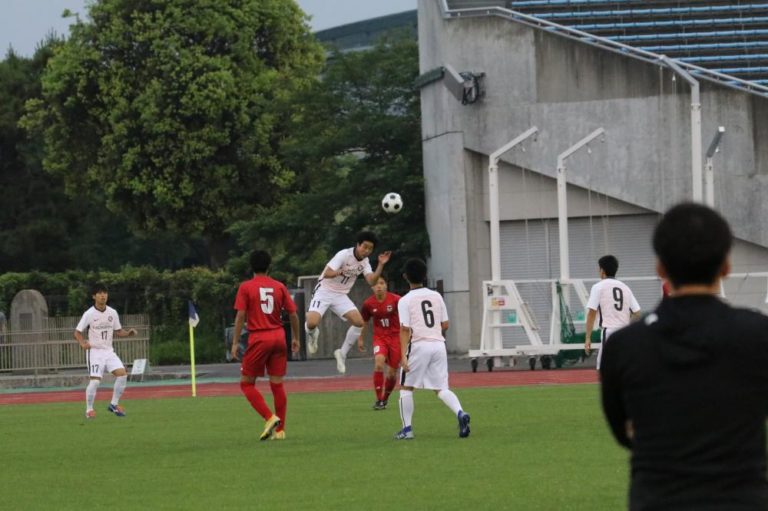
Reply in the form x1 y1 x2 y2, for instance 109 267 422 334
232 37 429 288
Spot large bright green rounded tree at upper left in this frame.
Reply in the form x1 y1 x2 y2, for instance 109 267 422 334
24 0 323 266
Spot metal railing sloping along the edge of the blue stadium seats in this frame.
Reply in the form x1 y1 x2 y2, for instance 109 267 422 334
440 0 768 97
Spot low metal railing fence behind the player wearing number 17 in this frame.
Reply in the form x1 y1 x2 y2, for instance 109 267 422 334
0 314 150 372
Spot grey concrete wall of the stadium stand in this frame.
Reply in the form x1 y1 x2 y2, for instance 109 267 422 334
418 0 768 351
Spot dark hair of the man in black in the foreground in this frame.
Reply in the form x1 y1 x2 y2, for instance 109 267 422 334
653 203 733 287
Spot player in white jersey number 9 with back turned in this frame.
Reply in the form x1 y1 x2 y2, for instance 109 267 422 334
584 255 640 370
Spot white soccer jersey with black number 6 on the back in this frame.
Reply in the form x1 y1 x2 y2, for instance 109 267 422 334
397 287 448 342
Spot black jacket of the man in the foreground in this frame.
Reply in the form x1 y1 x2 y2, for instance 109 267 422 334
600 295 768 511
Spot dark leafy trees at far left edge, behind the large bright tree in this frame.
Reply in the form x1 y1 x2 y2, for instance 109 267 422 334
0 40 205 272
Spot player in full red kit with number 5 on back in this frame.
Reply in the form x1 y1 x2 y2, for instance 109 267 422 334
232 250 299 440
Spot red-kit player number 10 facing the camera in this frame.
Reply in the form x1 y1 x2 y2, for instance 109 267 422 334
357 277 400 410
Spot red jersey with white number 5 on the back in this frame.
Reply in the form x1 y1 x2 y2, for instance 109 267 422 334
235 275 296 332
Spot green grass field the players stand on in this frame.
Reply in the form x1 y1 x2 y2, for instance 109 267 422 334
0 385 628 511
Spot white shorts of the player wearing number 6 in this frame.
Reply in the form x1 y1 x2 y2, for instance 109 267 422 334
400 341 448 390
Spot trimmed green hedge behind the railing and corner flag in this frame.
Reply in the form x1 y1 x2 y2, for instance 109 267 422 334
0 266 239 365
